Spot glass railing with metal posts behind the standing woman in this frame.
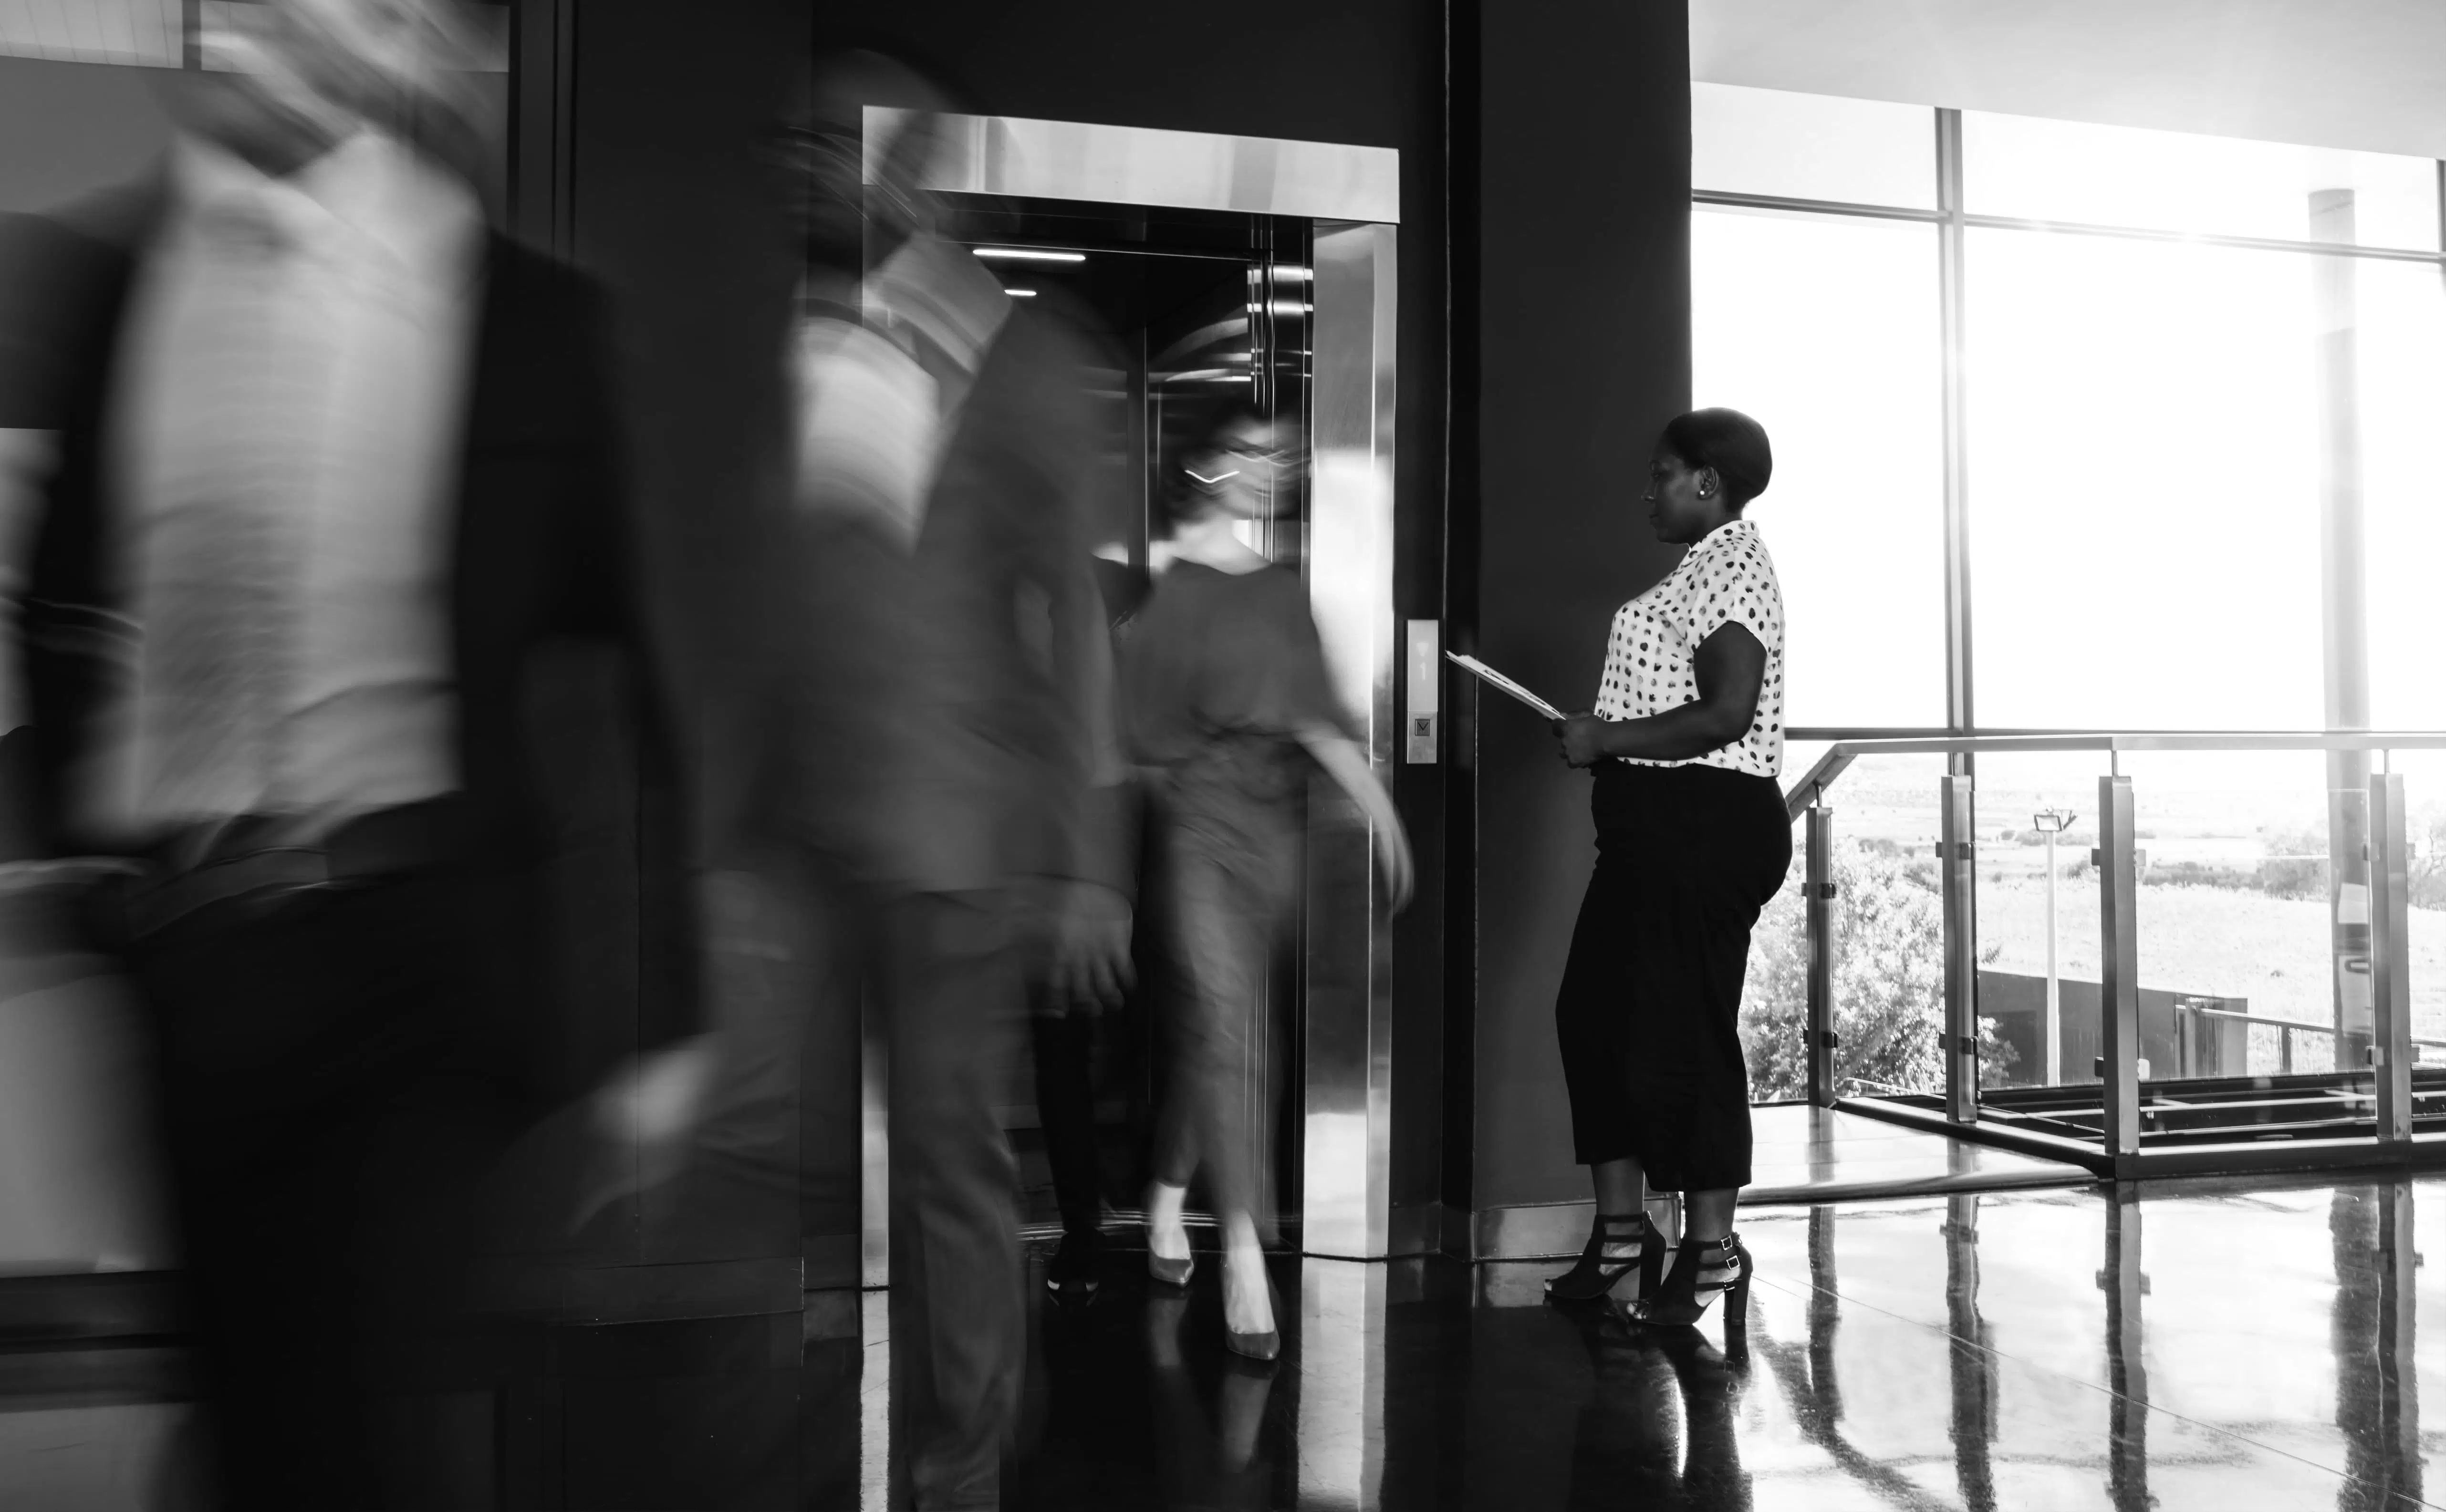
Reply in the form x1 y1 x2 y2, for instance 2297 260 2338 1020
1790 732 2446 1172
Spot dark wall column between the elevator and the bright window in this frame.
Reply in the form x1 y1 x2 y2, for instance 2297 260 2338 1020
1456 0 1690 1211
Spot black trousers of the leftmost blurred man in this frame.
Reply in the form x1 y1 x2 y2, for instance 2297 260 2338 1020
130 878 511 1510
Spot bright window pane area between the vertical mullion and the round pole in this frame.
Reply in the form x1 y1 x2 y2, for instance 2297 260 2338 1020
1964 228 2321 729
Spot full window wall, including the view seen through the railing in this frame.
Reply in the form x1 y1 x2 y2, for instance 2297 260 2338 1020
1690 86 2446 1098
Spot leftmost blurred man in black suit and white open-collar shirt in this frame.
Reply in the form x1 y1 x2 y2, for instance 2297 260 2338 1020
0 0 692 1510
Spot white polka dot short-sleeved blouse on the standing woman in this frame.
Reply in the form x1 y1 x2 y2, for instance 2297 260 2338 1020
1597 518 1783 778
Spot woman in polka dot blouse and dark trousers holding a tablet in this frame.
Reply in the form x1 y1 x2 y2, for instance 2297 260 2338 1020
1546 409 1793 1331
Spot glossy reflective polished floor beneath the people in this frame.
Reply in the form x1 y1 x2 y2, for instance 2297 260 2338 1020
0 1177 2446 1512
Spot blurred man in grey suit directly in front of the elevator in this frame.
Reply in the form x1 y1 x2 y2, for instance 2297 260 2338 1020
724 54 1130 1507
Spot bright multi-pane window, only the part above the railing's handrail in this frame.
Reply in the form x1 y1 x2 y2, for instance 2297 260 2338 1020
1690 86 2446 734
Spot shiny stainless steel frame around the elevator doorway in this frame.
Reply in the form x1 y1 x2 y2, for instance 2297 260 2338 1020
864 105 1402 1262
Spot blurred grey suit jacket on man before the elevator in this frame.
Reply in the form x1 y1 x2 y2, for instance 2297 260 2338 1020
775 306 1130 895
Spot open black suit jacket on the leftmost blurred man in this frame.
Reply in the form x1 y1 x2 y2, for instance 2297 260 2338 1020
0 184 697 1094
